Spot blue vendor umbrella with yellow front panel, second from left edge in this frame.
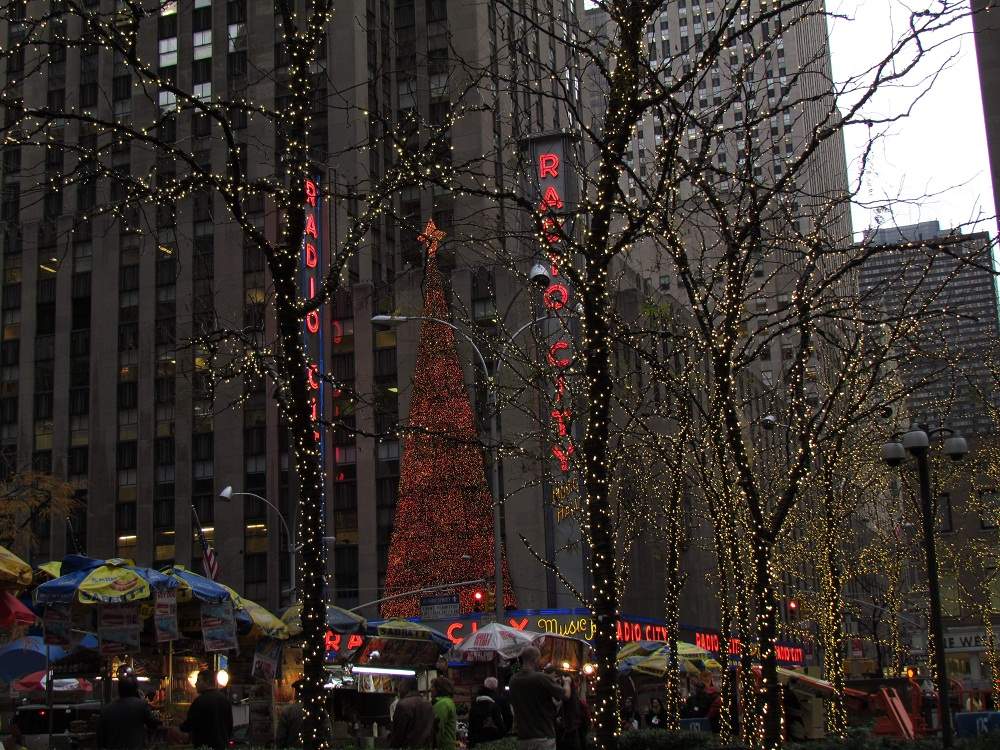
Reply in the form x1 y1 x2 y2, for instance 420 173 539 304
34 555 178 604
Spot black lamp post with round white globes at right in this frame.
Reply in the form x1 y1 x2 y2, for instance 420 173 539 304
882 424 969 748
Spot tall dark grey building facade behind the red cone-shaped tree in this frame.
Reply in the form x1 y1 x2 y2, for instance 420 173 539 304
0 0 711 624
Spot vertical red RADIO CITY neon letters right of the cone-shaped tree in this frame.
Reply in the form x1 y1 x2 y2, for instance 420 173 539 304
536 148 574 473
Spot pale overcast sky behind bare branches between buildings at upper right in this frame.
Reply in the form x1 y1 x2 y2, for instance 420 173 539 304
827 0 996 241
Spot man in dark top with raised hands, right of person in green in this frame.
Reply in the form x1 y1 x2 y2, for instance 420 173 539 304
510 646 570 750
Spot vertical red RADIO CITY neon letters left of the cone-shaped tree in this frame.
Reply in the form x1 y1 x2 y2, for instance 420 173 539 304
301 180 323 455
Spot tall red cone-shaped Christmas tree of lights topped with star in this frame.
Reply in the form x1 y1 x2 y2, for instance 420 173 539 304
382 221 516 617
